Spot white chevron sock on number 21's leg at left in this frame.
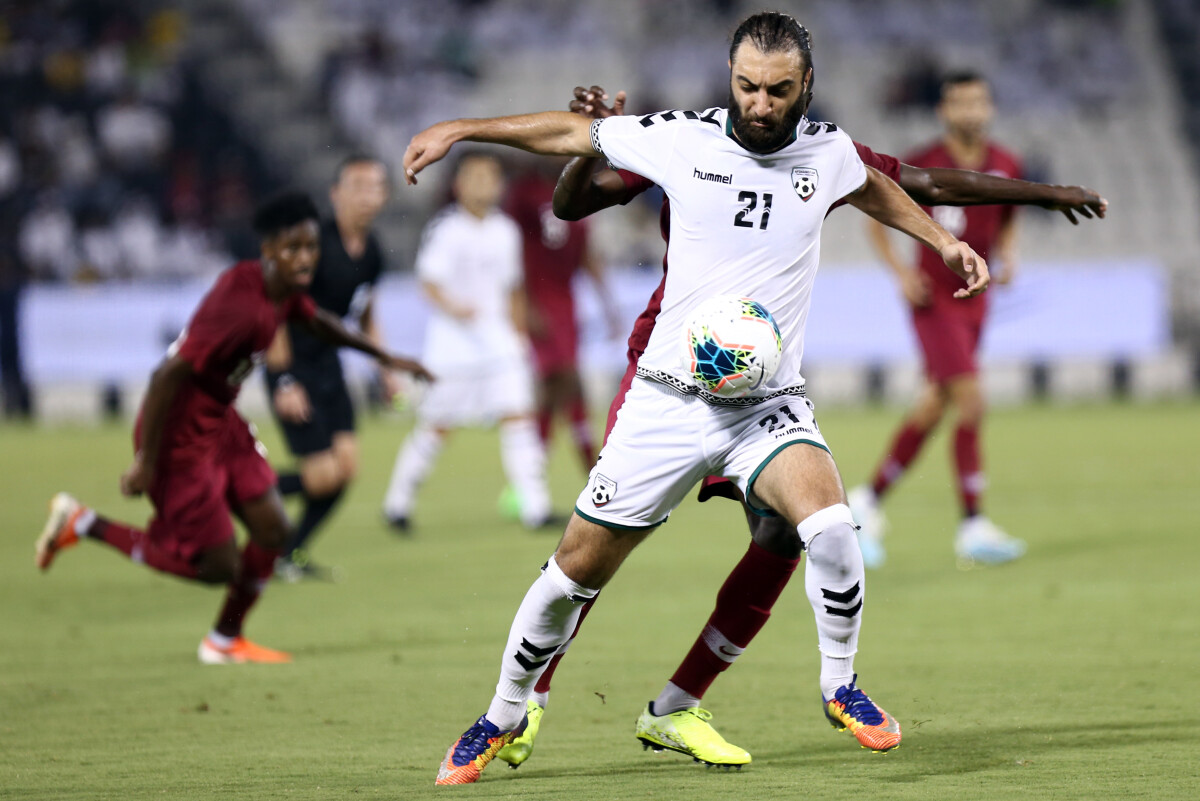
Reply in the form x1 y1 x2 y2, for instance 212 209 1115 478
487 556 599 731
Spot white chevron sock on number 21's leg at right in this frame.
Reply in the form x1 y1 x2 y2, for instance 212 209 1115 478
796 504 865 699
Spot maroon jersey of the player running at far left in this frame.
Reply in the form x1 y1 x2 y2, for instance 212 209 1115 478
146 259 317 458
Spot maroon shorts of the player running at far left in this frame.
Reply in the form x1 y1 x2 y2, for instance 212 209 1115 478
140 411 275 561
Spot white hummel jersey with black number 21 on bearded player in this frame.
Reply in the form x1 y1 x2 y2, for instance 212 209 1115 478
592 108 866 405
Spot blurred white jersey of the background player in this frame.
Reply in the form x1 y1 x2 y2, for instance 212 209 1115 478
416 205 524 373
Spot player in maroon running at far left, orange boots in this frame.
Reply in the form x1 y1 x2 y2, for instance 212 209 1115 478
36 192 430 664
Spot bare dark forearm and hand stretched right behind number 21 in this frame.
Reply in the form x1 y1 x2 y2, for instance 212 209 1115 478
900 164 1109 225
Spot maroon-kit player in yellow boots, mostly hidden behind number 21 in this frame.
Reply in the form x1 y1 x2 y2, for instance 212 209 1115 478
497 86 1108 767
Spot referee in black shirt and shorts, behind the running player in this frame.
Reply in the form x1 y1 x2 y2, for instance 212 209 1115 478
266 153 398 582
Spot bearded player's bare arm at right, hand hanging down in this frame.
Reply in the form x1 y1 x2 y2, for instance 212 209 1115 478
846 167 989 297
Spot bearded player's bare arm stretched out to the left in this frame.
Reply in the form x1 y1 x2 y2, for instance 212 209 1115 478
404 112 596 185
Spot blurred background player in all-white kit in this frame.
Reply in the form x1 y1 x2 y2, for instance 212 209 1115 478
383 152 556 531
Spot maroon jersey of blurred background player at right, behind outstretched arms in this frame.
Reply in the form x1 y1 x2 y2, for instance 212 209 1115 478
905 141 1022 298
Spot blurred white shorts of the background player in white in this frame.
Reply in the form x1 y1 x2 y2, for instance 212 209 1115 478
416 359 534 428
